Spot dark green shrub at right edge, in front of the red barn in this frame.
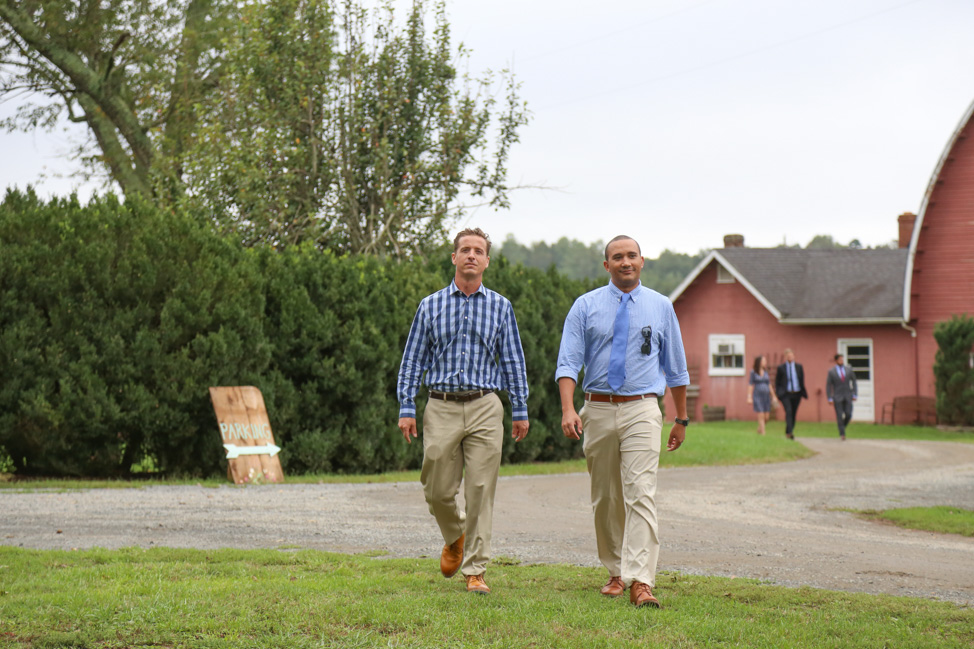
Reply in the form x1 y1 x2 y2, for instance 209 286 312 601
933 314 974 426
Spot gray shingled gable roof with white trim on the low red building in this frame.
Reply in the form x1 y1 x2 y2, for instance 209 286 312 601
670 247 908 324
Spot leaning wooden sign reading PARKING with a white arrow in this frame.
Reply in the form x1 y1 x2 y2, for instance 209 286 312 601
210 385 284 484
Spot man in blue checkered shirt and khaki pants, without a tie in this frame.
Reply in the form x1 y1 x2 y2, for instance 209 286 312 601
397 228 528 595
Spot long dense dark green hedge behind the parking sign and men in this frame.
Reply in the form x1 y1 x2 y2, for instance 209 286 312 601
0 192 589 477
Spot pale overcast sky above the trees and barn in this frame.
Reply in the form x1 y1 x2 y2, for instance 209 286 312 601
0 0 974 257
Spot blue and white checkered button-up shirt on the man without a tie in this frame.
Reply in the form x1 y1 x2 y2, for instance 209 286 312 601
396 282 528 421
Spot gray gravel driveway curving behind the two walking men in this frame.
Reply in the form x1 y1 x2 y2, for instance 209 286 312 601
0 437 974 606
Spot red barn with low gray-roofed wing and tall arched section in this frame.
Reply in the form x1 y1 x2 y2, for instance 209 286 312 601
670 104 974 423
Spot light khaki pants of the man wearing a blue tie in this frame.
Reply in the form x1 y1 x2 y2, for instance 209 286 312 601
579 399 663 586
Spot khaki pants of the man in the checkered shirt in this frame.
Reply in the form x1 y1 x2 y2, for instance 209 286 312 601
420 393 504 575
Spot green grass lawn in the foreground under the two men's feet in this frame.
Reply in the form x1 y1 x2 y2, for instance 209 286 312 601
0 547 974 649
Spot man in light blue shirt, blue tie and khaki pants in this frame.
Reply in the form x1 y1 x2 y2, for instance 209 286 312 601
555 236 690 608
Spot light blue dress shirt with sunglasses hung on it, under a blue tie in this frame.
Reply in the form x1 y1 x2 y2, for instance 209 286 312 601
555 282 690 396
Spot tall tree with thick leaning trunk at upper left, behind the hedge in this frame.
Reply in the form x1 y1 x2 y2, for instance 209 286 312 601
0 0 227 195
